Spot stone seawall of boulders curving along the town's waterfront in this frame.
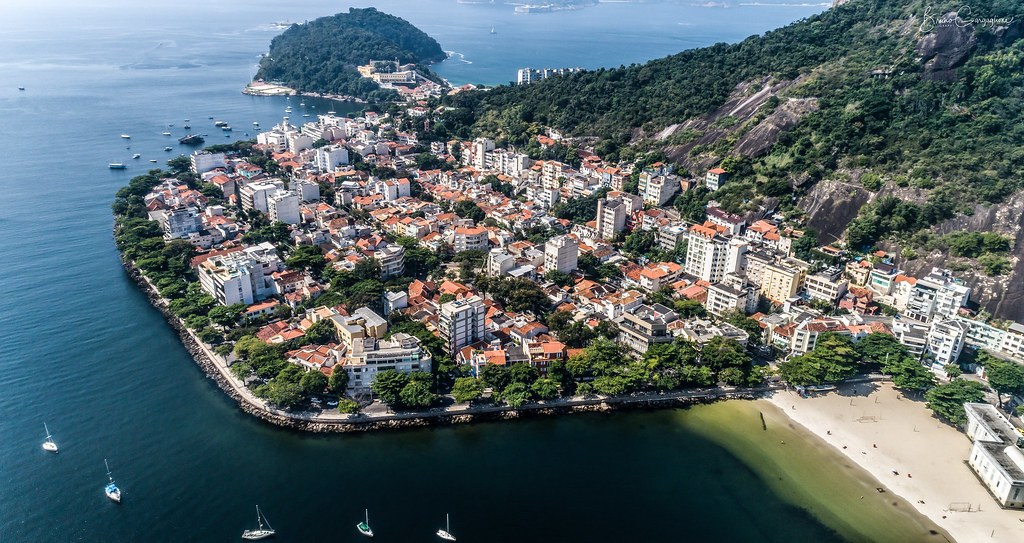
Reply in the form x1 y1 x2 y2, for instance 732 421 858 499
121 252 777 433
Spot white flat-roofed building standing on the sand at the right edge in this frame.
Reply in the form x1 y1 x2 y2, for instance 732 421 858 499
964 404 1024 509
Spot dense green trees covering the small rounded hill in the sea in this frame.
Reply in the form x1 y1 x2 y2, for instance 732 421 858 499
256 7 444 100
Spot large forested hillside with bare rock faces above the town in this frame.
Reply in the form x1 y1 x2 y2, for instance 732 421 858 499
447 0 1024 319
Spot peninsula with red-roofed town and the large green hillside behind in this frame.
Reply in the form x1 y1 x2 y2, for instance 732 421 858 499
114 0 1024 534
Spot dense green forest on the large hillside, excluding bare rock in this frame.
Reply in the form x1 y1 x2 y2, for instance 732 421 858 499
445 0 1024 245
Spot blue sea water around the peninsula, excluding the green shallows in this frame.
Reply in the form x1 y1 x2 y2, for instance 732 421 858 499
0 0 942 543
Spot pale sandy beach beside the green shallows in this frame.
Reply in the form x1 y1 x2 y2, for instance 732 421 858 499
768 383 1024 543
